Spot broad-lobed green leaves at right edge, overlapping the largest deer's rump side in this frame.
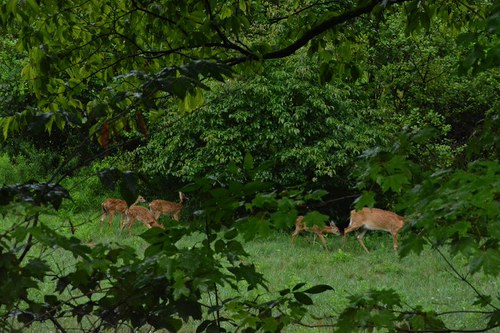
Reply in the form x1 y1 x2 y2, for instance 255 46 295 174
357 115 500 329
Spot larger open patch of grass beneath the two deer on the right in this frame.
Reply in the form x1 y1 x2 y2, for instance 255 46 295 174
243 233 500 332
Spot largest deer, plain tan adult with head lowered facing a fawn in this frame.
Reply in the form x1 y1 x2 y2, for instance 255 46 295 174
342 207 405 253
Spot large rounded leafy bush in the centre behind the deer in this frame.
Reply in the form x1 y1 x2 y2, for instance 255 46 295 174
135 56 383 186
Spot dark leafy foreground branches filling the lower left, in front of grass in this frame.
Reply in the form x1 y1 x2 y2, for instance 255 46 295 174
0 158 340 332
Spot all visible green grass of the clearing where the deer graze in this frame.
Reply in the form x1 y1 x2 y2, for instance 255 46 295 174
1 209 500 332
